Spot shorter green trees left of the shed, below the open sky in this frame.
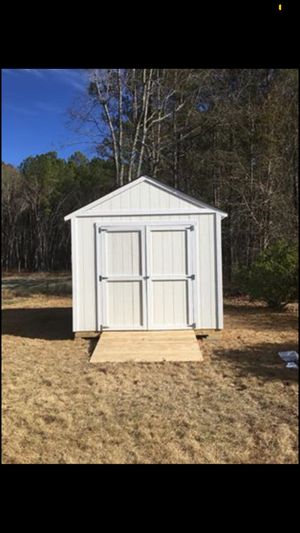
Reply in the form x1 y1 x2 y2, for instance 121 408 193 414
1 152 114 271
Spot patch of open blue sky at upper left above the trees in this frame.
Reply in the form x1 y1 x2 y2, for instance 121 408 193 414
2 69 95 166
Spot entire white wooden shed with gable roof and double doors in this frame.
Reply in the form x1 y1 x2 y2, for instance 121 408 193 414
65 176 227 332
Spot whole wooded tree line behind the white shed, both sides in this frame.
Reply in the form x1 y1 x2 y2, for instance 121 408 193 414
2 68 299 281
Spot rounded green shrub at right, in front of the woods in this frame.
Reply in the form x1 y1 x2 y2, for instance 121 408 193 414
238 240 298 310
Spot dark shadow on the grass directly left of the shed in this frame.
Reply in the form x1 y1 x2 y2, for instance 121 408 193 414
2 307 73 340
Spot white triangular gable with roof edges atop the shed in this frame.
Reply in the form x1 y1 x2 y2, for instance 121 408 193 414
65 176 227 220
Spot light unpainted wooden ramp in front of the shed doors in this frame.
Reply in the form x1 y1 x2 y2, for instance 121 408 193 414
90 330 203 363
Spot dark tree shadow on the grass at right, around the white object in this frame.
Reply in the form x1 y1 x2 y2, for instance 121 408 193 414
214 342 299 382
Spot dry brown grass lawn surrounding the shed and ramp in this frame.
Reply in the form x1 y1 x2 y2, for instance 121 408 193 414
2 288 298 464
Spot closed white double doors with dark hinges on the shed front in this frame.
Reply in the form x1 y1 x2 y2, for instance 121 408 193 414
97 223 197 330
